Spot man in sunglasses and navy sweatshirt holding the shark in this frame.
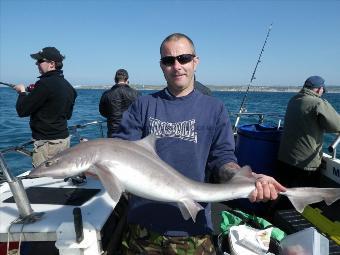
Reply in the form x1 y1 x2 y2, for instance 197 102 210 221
114 33 285 254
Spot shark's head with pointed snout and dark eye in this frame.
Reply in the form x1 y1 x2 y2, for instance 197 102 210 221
29 146 94 178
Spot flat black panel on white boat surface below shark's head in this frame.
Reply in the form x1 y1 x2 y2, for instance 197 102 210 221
3 187 100 206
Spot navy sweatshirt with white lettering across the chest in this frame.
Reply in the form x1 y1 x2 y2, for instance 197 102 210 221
114 89 236 236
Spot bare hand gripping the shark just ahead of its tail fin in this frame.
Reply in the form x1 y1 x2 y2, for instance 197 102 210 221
249 173 286 202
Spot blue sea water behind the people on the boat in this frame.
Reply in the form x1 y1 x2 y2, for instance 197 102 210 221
0 87 340 175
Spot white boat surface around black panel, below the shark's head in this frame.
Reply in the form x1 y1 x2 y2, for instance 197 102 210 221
0 177 116 242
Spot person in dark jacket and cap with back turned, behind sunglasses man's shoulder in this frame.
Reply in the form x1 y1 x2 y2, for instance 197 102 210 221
99 69 140 137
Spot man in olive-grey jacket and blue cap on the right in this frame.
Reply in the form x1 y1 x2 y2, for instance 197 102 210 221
277 76 340 187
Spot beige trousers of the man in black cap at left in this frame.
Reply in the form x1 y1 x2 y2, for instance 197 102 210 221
32 136 71 167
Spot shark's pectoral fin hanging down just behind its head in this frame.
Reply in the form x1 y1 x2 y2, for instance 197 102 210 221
95 164 124 203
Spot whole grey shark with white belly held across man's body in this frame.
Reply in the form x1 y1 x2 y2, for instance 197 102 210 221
29 135 340 221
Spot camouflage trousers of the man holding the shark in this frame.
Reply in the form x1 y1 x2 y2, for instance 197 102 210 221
122 225 216 255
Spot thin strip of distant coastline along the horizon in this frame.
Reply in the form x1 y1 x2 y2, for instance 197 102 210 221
74 84 340 93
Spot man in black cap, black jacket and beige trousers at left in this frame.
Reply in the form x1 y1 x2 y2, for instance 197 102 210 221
14 47 77 167
